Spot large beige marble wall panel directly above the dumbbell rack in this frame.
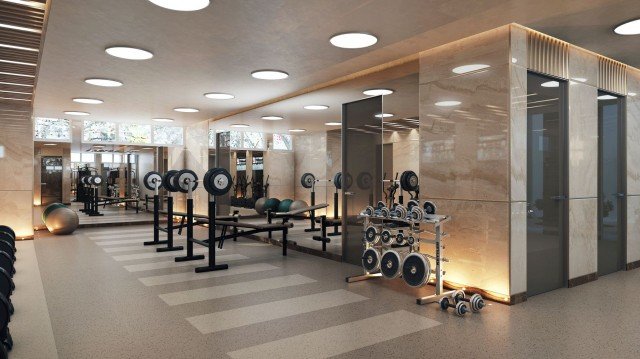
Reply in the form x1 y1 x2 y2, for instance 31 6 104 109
420 65 511 201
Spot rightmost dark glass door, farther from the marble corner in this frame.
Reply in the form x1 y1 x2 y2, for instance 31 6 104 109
598 91 626 275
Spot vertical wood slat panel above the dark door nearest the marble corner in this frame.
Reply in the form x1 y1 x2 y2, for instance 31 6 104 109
527 31 569 79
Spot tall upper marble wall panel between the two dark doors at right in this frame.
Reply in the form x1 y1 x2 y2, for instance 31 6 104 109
568 83 598 198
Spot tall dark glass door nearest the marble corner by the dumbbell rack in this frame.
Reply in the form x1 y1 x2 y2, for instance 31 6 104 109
527 73 567 296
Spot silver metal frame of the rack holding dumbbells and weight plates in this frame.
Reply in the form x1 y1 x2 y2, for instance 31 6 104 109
346 214 455 305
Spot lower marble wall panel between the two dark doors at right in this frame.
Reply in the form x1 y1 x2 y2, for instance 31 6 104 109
568 198 598 279
